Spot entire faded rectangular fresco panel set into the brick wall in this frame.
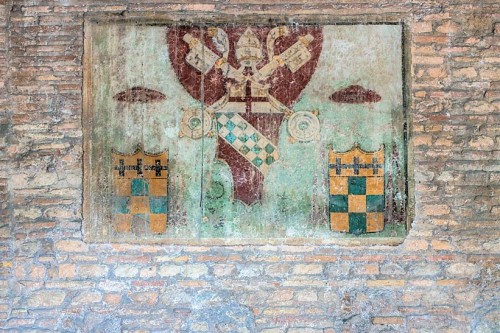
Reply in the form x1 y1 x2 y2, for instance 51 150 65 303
86 23 406 240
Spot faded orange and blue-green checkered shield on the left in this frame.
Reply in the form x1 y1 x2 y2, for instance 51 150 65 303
112 147 168 236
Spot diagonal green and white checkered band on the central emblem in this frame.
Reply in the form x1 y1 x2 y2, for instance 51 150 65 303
216 113 279 175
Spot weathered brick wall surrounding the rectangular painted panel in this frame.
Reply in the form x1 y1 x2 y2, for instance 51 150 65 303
0 0 500 333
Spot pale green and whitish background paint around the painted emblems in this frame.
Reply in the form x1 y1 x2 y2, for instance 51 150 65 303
92 24 404 238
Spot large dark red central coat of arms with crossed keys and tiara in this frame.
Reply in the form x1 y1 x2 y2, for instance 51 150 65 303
168 26 322 205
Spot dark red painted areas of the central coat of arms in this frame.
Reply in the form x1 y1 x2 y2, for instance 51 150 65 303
167 26 323 205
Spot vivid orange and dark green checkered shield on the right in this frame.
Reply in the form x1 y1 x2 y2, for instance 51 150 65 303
328 144 385 234
